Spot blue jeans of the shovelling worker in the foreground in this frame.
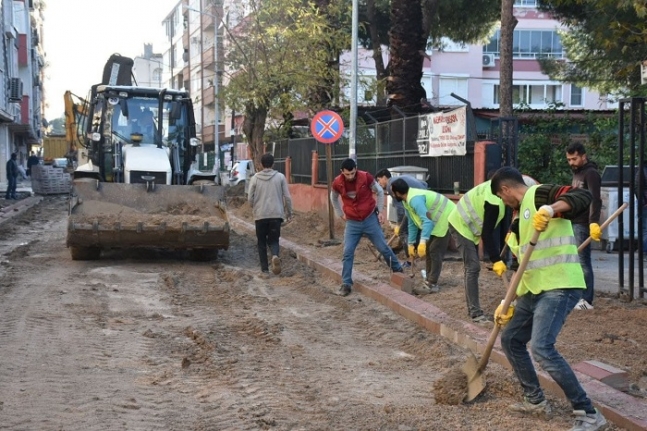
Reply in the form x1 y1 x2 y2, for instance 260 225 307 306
501 289 593 411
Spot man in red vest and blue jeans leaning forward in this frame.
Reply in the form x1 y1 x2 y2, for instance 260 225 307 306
330 159 402 296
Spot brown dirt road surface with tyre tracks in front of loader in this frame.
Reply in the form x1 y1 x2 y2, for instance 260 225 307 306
0 197 613 431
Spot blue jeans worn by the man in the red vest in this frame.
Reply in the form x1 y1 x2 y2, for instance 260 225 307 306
341 213 402 285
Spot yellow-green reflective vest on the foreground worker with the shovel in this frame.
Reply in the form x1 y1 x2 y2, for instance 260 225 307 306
511 186 586 296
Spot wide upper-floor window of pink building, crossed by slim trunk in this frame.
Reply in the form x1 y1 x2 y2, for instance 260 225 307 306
483 30 564 58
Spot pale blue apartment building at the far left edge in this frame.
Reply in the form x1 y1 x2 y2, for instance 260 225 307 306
0 0 45 179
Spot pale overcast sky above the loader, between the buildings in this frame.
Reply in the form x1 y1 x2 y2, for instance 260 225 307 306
42 0 179 121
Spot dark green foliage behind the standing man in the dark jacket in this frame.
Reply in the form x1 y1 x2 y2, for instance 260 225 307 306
518 109 628 184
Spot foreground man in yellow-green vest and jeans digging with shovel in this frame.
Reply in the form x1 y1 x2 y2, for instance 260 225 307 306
491 167 607 431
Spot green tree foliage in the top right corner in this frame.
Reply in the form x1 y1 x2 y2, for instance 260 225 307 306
541 0 647 95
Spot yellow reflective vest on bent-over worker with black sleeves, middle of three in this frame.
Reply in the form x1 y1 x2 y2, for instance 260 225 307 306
449 181 505 244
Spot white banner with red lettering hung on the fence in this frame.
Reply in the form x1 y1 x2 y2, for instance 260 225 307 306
417 107 467 157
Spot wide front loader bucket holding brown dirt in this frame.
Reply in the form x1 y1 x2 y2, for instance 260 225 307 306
67 178 229 260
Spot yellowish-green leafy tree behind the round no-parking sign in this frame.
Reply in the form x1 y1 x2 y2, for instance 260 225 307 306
223 0 350 166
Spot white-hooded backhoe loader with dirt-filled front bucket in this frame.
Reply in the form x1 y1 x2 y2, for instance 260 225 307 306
66 54 230 260
